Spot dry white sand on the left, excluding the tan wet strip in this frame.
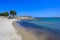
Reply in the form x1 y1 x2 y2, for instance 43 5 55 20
0 18 22 40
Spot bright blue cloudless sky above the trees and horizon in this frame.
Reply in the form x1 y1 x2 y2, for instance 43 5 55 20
0 0 60 17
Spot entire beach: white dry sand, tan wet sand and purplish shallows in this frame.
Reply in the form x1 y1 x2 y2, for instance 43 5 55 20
0 18 60 40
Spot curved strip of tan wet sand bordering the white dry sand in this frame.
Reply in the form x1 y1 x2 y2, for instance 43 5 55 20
12 21 38 40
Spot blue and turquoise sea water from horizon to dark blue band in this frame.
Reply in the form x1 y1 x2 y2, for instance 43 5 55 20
16 18 60 34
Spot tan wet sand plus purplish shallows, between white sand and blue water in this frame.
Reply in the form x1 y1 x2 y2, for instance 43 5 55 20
12 21 60 40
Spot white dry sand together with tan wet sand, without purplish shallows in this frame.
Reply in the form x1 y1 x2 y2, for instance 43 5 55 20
0 18 37 40
